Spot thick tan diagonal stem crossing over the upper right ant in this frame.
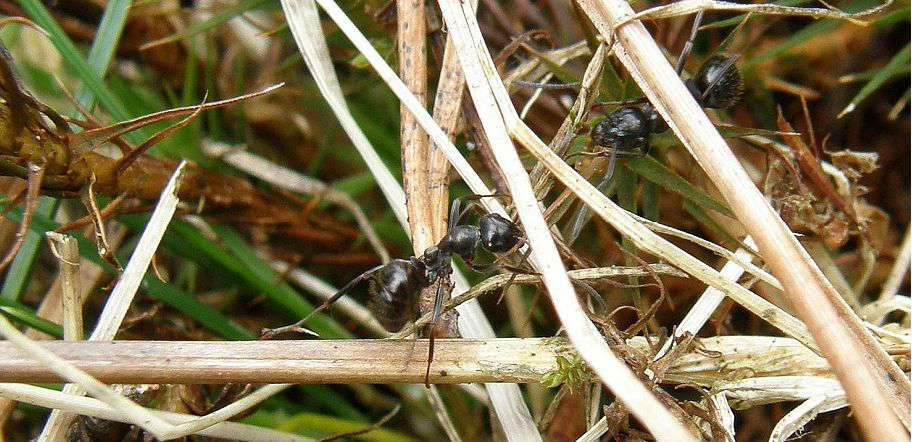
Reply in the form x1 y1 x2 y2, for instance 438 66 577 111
580 0 910 440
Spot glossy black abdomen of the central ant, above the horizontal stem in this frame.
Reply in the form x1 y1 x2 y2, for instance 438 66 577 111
368 258 425 332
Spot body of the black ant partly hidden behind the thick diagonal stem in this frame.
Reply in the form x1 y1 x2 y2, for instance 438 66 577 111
591 55 744 156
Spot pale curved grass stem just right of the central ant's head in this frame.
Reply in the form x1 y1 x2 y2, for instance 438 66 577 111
439 1 692 440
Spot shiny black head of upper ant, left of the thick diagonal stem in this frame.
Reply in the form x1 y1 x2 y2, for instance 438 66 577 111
591 105 660 152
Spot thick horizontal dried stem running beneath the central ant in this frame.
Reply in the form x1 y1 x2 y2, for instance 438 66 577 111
0 336 884 386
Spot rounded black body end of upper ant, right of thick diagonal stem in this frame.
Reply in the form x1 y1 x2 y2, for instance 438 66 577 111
686 54 744 109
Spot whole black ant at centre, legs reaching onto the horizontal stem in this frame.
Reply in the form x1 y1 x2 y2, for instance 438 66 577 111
261 194 528 385
